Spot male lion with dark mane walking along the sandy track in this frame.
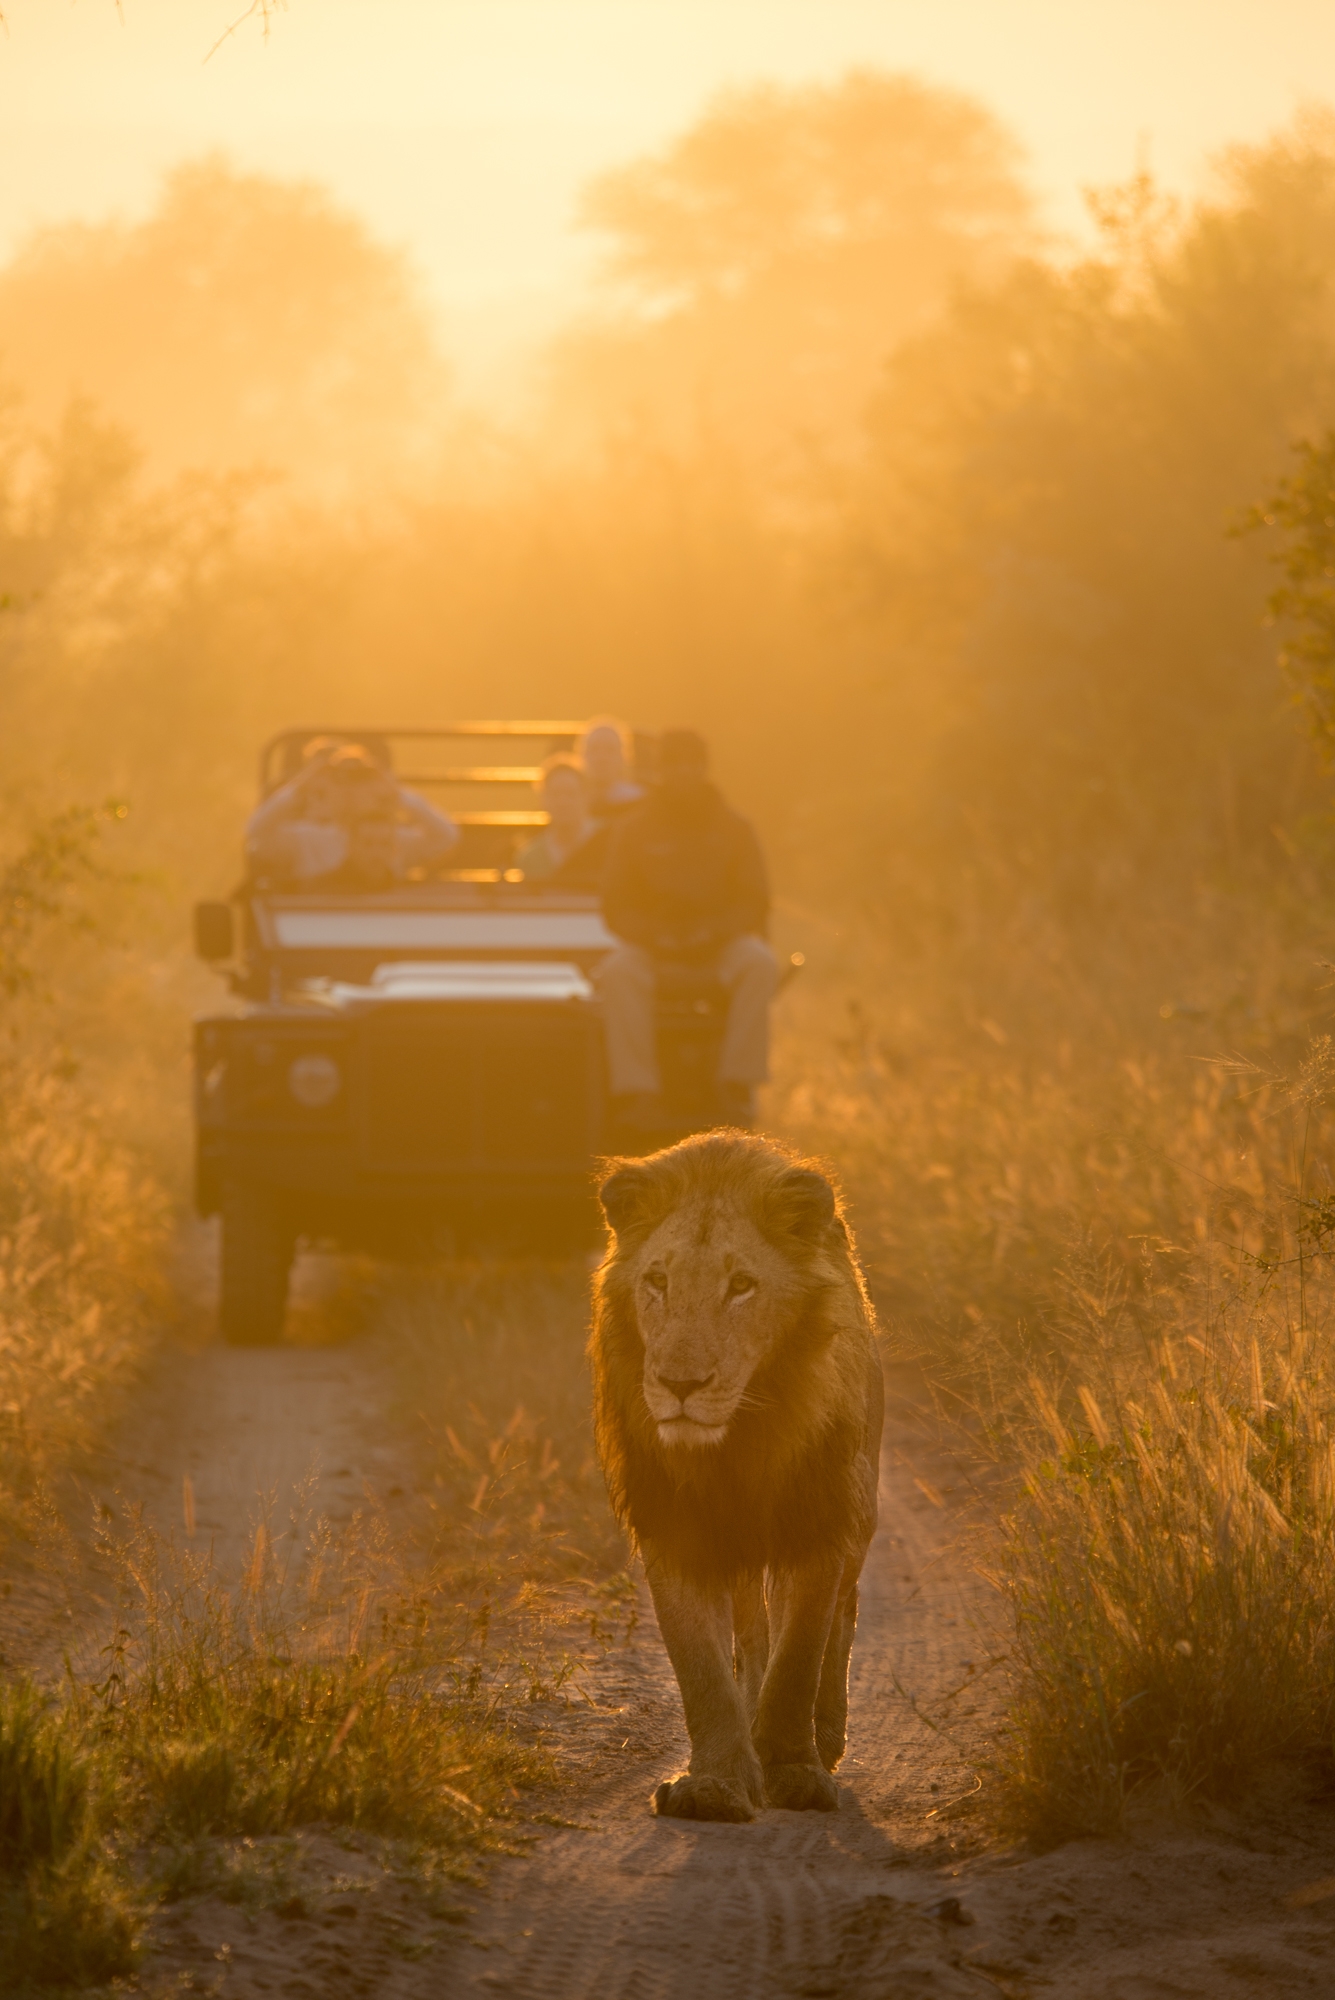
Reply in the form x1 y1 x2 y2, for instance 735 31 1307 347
590 1132 883 1820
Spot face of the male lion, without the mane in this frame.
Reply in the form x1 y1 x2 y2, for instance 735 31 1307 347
628 1204 797 1448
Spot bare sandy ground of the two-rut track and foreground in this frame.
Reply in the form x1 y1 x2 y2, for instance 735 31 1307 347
0 1248 1335 2000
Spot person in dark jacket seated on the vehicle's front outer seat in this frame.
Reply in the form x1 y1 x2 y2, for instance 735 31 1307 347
598 730 779 1130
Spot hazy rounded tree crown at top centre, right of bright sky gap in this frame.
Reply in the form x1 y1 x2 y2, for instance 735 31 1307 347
556 70 1029 458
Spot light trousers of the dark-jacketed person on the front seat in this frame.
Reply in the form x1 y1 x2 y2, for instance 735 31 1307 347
596 936 779 1098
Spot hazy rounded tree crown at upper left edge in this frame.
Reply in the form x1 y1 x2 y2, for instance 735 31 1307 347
0 158 446 492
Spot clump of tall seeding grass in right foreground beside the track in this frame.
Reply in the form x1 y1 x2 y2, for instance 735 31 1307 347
993 1284 1335 1840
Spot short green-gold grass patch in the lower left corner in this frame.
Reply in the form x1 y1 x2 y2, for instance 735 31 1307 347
0 1512 550 1990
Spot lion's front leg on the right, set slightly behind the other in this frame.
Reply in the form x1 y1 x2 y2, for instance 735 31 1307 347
751 1558 841 1812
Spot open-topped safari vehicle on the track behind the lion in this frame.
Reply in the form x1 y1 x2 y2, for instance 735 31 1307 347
194 722 787 1344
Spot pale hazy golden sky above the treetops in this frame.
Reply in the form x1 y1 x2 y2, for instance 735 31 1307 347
0 0 1335 378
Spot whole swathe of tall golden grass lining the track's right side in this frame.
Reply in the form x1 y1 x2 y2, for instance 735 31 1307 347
777 894 1335 1840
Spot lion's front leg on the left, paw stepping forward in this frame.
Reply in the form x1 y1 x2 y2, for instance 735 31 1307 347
646 1550 765 1820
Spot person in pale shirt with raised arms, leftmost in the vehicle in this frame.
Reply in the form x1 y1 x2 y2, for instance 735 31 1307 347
246 738 460 884
